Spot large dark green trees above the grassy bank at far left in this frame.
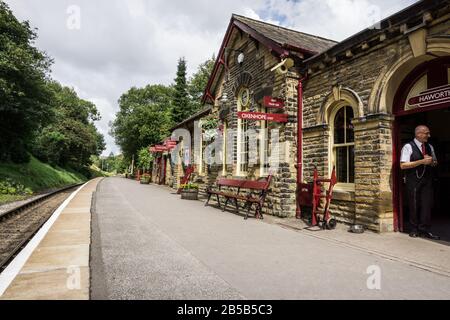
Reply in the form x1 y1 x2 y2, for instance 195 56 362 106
0 0 105 176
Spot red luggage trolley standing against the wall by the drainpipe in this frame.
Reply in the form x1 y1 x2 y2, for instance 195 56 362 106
297 168 337 230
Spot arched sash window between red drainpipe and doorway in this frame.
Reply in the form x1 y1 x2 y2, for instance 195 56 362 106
332 106 355 184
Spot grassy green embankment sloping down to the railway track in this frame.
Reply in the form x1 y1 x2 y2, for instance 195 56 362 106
0 156 86 192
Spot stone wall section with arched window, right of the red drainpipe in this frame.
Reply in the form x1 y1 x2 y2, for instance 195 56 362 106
302 1 450 232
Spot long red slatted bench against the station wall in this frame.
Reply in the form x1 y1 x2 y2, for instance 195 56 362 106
205 175 272 220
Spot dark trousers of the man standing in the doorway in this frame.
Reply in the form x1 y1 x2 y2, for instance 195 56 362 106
406 178 433 231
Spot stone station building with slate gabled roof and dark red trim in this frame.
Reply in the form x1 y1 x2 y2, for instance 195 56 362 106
153 0 450 232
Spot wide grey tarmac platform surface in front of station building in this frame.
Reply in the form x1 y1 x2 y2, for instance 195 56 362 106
91 178 450 299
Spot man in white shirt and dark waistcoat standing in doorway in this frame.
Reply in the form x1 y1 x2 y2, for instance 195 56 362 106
400 126 440 240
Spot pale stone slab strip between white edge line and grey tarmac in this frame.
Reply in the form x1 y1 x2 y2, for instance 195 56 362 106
0 179 99 300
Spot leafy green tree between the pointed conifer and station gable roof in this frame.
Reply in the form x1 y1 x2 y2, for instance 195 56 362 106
188 55 216 114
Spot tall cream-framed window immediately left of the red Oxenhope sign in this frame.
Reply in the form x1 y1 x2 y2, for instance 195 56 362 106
237 87 250 175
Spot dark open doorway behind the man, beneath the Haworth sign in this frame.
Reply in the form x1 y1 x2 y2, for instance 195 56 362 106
397 107 450 242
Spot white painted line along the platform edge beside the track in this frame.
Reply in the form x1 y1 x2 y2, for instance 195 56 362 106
0 181 90 297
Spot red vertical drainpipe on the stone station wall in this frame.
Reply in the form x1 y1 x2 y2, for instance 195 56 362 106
296 75 308 219
